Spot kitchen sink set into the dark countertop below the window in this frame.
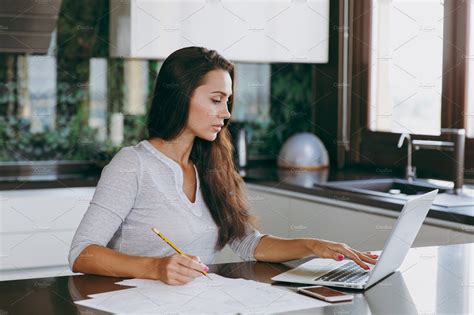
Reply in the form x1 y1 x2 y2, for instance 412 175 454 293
315 178 450 198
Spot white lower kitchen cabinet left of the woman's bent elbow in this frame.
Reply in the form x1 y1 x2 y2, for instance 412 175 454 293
0 187 95 280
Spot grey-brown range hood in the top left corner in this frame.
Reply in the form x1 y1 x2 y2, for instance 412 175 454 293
0 0 61 54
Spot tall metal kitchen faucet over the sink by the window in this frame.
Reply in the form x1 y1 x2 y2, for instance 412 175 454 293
398 128 466 194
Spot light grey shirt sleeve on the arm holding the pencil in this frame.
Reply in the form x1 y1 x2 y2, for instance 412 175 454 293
68 147 141 270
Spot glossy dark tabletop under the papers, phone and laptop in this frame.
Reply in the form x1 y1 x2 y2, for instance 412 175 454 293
0 243 474 314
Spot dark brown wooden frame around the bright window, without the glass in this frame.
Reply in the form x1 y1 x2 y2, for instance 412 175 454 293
347 0 474 178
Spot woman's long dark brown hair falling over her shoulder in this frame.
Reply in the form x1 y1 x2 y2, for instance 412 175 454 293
148 46 255 250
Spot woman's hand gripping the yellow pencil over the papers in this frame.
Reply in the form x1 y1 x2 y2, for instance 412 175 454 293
156 254 209 285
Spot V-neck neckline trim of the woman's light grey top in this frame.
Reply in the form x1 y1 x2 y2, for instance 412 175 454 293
143 140 200 209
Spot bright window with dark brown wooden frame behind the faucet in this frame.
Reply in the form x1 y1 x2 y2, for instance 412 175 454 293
344 0 474 179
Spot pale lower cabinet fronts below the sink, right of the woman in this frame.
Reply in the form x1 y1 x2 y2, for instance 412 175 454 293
214 184 474 262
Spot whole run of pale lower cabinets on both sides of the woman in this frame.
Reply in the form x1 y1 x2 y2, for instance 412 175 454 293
0 184 474 280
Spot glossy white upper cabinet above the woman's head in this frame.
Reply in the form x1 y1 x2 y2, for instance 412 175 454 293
109 0 329 63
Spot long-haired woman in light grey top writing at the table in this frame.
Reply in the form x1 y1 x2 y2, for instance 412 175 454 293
69 47 377 285
